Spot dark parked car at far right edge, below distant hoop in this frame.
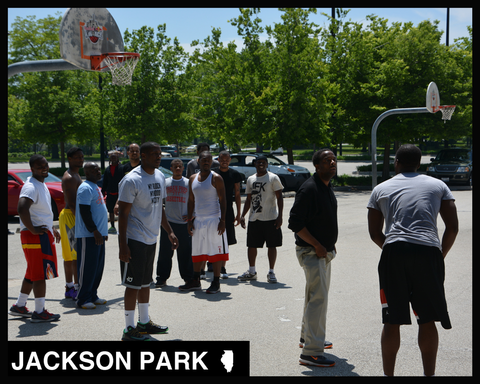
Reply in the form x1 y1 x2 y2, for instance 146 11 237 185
427 148 473 185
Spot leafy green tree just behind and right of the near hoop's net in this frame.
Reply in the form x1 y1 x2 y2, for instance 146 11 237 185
104 24 191 143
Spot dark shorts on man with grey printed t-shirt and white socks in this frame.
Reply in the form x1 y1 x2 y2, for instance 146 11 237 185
120 239 157 289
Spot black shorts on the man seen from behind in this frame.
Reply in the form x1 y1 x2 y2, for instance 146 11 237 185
378 241 452 329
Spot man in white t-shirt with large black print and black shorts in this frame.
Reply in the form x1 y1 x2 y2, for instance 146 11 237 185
238 156 283 283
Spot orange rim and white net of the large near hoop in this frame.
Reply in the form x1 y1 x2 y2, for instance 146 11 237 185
91 52 140 85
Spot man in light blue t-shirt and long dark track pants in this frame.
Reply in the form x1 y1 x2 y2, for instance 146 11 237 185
75 162 108 309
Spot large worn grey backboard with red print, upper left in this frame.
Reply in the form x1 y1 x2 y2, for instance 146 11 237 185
59 8 124 71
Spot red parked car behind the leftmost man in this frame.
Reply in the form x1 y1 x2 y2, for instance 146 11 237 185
7 169 65 220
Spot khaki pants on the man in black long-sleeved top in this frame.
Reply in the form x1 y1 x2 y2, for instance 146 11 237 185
295 246 335 356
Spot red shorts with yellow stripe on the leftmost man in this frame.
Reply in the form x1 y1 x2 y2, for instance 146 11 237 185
20 231 58 281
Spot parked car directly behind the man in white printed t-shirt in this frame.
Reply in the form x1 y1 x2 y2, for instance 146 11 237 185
215 153 311 192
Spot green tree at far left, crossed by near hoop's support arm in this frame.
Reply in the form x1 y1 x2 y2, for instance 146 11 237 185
9 16 101 166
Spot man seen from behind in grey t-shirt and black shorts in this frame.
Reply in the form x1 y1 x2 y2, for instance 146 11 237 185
367 144 458 376
